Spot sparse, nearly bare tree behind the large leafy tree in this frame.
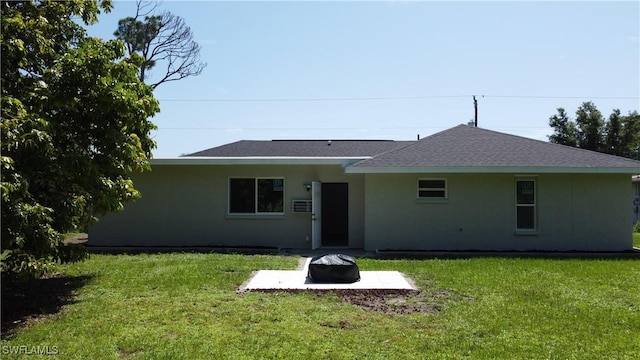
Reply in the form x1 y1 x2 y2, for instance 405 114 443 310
113 0 206 89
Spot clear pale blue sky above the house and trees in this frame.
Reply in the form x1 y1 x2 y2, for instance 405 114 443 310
88 1 640 158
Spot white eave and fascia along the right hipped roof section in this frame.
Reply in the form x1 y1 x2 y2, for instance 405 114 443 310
345 166 640 175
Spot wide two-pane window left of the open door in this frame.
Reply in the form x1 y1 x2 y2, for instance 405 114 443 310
229 178 284 214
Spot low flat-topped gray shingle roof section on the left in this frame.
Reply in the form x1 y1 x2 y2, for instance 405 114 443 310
185 140 415 158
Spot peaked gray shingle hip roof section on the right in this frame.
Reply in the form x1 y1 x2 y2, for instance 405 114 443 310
351 125 640 173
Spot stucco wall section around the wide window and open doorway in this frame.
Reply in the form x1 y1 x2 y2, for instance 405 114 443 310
89 165 364 249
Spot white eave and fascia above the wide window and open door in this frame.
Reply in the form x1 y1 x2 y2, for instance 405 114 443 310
151 156 371 166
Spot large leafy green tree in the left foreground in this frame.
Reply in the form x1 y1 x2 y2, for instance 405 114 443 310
0 0 159 275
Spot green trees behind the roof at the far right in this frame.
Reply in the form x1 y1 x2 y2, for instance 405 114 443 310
549 102 640 159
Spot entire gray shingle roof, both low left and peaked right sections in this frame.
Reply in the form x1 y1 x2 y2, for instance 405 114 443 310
178 125 640 174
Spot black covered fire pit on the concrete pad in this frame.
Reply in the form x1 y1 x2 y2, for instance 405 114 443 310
307 254 360 283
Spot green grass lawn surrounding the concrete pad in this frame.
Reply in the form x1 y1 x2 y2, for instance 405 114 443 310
0 253 640 359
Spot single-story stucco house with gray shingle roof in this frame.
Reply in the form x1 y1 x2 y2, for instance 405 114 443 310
89 125 640 251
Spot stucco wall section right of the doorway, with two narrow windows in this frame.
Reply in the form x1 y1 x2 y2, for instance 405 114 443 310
365 174 632 251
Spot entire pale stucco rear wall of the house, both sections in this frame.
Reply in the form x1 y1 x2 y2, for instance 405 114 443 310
89 165 632 251
